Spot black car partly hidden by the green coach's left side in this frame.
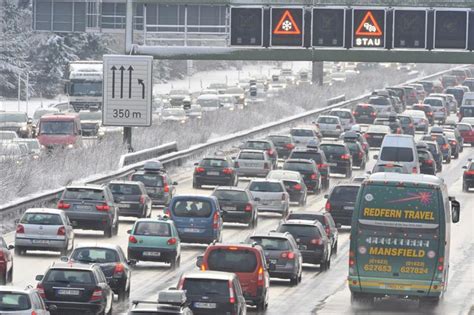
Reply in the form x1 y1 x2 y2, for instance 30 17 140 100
324 184 360 226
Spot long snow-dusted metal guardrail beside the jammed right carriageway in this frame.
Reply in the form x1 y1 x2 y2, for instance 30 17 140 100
0 67 460 235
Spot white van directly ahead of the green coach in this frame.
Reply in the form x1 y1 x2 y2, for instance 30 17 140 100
374 134 420 174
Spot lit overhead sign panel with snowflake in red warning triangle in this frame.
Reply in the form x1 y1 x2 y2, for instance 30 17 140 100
271 8 303 47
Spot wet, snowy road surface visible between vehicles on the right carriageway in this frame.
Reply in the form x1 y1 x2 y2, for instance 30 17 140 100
6 126 474 314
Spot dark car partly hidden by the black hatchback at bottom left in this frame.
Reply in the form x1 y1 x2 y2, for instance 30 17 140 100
67 244 132 301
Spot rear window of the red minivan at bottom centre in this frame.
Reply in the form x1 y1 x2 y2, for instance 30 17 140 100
207 247 257 272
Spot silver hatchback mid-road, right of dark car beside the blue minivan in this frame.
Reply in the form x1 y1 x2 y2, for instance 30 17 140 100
248 179 290 217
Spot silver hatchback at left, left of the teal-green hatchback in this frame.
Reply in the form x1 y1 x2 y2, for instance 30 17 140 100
15 208 74 256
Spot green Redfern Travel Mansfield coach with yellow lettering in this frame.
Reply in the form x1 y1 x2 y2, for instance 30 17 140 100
348 173 460 306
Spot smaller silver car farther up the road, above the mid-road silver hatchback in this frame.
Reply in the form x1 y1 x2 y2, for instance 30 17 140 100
234 149 273 177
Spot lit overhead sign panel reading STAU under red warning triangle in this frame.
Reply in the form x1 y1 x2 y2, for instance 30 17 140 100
352 9 385 48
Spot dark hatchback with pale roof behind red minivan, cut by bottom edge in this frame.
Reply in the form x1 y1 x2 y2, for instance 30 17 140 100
178 271 247 315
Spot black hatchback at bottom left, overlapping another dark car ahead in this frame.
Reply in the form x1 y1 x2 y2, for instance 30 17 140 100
36 262 113 315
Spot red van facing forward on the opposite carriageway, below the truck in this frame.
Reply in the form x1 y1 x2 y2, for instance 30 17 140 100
36 113 82 149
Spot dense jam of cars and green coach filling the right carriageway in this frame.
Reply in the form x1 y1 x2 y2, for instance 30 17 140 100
0 67 474 315
